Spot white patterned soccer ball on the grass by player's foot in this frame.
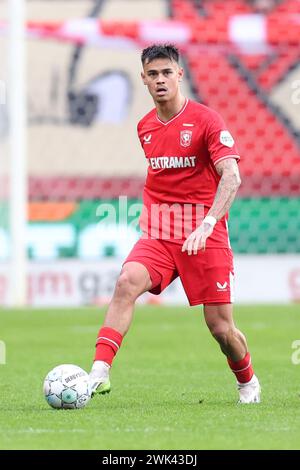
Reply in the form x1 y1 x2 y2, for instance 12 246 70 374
43 364 91 409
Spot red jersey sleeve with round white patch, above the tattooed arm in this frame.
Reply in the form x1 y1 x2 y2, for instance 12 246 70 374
206 113 240 165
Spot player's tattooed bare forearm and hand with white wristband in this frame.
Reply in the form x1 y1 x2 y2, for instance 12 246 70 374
182 158 241 255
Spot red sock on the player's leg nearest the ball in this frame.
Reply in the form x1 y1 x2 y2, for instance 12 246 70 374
94 326 123 366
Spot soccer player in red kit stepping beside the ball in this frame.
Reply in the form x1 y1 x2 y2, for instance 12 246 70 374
90 45 260 403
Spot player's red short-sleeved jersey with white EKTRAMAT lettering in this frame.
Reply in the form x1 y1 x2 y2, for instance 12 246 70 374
138 100 240 248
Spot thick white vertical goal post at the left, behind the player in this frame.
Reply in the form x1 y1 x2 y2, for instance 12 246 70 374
7 0 27 306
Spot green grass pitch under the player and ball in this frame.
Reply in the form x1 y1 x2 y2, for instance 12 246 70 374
0 305 300 450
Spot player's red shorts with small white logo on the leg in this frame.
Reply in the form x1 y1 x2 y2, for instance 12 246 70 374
124 238 234 305
